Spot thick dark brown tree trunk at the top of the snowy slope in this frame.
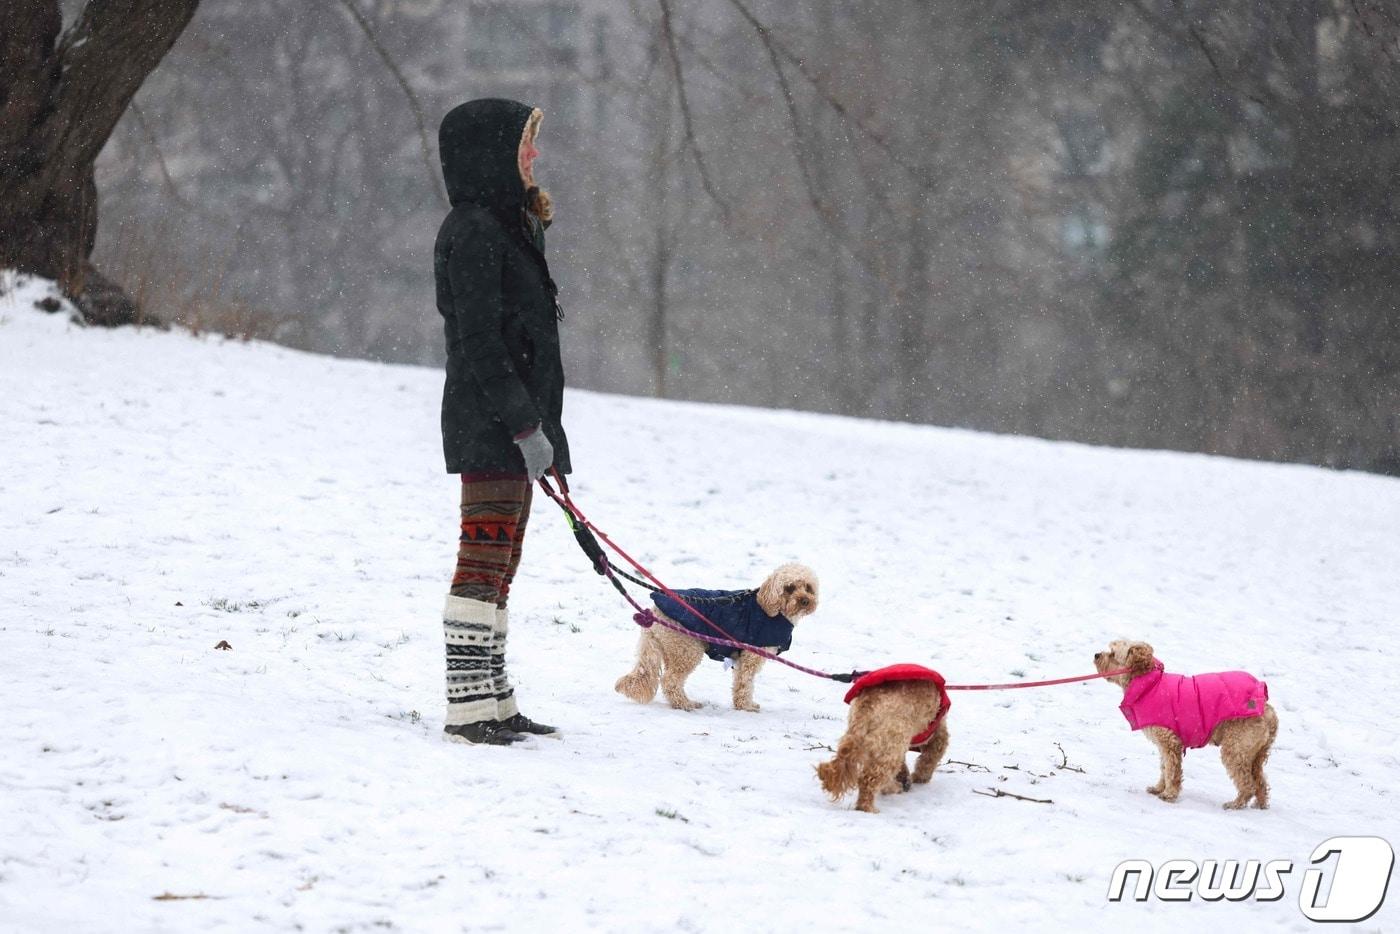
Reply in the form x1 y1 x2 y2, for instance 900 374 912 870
0 0 199 325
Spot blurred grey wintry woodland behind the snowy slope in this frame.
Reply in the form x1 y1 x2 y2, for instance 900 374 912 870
71 0 1400 472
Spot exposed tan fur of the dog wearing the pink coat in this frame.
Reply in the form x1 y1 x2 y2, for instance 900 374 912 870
1093 639 1278 811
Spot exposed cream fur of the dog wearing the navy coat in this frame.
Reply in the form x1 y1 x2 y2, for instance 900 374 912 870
615 564 819 713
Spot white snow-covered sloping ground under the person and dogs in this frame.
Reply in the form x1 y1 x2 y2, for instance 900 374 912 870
0 274 1400 931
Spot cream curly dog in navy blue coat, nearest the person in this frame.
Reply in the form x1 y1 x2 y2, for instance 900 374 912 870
616 564 818 713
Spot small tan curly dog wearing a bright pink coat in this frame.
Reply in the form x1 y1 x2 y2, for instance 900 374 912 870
1093 640 1278 811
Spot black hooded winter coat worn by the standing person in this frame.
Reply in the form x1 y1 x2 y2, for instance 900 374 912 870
433 99 571 476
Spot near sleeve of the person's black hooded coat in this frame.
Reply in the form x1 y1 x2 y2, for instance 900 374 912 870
447 216 540 434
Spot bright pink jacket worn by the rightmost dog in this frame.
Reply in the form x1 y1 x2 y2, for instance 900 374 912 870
1119 658 1268 749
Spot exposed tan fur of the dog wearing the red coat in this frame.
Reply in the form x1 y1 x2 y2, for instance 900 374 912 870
816 681 948 814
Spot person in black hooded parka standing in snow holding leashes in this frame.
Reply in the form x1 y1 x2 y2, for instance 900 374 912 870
433 98 571 745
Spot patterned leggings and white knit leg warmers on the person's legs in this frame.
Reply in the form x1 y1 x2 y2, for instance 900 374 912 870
442 475 532 725
